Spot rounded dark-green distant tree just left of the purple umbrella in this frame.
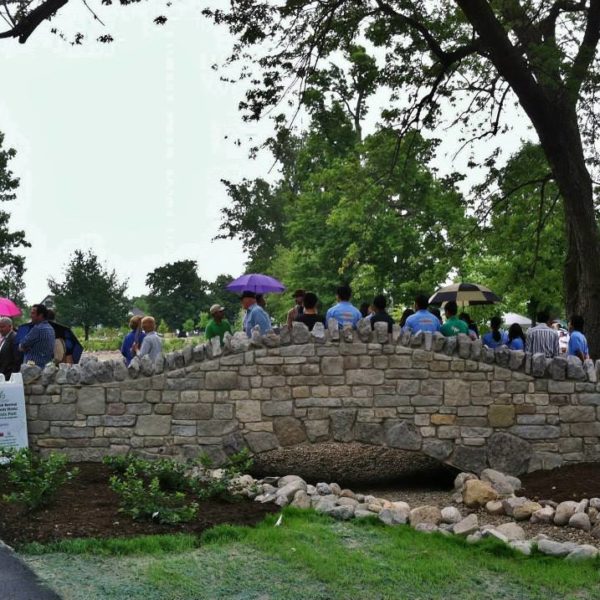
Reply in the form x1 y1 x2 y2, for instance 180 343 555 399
146 260 208 331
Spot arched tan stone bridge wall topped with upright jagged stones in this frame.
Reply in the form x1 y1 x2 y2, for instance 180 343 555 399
22 323 600 474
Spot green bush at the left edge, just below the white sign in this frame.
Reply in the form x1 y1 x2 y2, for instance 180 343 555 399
0 448 78 511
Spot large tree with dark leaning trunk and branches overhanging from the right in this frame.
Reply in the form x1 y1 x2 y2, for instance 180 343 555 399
205 0 600 357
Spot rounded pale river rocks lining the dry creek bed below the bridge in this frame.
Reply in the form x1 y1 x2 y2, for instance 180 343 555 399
224 469 600 560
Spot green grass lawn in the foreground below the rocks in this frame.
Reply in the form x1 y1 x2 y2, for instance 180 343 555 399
21 508 600 600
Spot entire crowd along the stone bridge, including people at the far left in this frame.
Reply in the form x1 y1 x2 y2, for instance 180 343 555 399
0 285 589 380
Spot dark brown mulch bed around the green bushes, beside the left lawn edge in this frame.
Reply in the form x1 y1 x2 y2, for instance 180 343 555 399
0 463 279 546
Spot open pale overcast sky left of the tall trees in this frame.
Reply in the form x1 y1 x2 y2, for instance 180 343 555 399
0 0 523 303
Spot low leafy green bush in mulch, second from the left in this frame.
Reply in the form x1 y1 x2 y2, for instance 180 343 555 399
105 457 198 524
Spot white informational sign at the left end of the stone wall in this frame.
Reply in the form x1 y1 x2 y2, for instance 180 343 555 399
0 373 28 450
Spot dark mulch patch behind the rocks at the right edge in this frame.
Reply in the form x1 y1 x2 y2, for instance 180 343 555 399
518 463 600 502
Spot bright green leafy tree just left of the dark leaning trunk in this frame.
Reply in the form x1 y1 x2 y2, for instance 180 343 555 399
460 143 566 319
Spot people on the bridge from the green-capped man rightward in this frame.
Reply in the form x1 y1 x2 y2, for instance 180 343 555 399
206 285 589 361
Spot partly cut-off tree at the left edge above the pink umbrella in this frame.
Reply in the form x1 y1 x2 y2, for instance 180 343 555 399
0 133 31 306
